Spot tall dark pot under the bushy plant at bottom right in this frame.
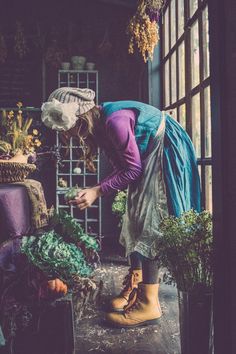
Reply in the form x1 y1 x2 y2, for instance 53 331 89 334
178 291 213 354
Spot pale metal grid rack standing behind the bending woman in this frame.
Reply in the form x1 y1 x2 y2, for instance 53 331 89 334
56 70 102 236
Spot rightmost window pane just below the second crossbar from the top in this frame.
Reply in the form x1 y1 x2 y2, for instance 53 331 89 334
204 86 212 157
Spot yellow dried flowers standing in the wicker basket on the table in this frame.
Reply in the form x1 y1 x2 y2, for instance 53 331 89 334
0 102 41 156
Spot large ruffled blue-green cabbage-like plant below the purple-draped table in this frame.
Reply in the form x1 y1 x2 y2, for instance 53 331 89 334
21 211 100 286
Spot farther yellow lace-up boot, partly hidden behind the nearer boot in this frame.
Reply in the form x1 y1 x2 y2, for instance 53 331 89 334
110 269 142 312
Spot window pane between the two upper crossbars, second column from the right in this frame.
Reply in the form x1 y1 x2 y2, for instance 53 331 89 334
191 21 200 88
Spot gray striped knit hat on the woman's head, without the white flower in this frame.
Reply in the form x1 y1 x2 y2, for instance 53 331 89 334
48 87 95 115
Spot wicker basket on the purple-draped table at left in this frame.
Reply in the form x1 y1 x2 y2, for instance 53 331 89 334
0 162 36 183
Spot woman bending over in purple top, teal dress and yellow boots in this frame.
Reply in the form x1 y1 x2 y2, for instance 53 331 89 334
42 87 200 327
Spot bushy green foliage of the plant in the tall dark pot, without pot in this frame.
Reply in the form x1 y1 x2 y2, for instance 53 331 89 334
158 210 213 291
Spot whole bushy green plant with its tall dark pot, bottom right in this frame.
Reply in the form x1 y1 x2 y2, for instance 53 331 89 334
158 210 213 354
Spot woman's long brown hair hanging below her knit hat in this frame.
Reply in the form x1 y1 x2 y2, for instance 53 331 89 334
60 106 101 172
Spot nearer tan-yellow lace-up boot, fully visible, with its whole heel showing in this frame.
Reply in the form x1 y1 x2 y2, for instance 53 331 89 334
107 283 162 328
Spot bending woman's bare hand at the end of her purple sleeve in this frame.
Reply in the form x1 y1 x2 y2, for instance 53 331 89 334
69 186 102 210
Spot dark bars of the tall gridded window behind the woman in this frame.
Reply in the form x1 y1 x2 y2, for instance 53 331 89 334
160 0 212 208
